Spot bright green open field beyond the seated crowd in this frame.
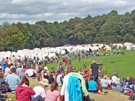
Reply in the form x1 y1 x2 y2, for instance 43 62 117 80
47 50 135 79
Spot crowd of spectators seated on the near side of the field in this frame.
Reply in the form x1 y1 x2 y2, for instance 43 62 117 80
0 55 135 101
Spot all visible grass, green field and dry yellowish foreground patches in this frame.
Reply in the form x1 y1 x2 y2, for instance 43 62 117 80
7 50 135 101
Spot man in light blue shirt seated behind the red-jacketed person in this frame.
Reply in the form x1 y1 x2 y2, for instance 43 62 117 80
5 68 21 92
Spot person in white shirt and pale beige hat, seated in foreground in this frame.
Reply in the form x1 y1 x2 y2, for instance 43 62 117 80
32 78 48 101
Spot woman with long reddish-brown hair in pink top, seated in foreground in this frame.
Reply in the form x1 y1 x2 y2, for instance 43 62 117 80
45 82 60 101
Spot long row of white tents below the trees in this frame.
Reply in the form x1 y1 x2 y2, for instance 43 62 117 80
0 42 135 61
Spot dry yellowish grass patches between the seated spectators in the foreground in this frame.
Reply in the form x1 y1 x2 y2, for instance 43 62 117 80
8 78 131 101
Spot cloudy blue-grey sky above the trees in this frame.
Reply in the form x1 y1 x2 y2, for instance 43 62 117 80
0 0 135 25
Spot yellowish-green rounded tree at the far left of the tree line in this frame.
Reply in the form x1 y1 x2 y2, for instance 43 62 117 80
0 26 26 51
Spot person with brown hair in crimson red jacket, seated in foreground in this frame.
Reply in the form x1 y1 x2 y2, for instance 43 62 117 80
15 77 35 101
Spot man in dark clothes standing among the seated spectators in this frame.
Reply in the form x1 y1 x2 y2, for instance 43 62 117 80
90 60 99 82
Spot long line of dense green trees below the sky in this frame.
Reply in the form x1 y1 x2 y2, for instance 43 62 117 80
0 10 135 51
